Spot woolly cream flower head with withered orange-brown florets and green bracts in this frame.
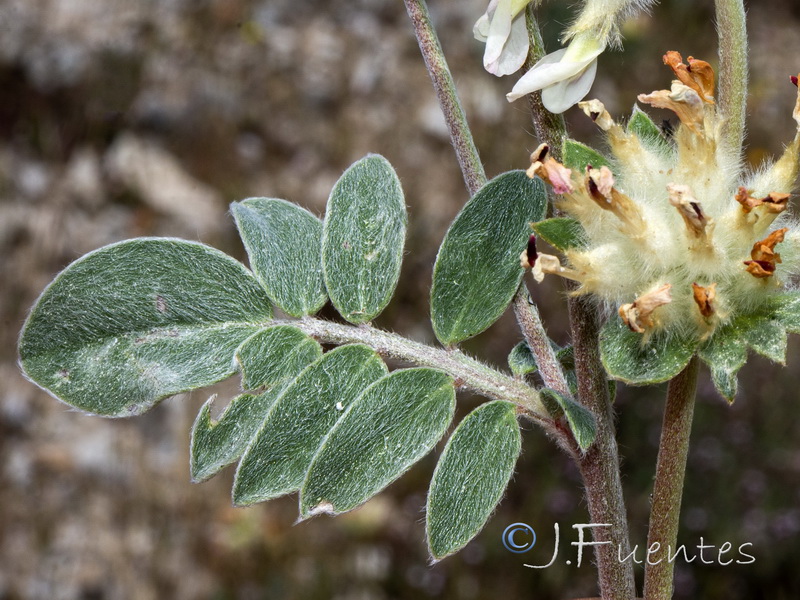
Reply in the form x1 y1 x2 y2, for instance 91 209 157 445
521 52 800 398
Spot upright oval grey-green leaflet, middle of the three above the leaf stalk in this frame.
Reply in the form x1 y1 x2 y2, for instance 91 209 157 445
322 155 408 324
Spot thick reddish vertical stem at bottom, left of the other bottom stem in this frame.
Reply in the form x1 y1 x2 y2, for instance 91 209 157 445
569 297 636 600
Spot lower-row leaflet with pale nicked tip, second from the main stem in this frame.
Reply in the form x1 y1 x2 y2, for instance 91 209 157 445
300 368 455 518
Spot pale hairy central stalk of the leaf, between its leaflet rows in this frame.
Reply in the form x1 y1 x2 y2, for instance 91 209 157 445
286 317 553 420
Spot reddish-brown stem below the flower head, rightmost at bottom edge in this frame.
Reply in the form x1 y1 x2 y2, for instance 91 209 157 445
644 356 699 600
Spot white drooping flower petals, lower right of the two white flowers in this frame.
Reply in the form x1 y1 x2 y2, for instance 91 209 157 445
506 32 605 113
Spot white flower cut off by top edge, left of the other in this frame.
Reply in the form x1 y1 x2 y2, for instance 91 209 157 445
473 0 530 77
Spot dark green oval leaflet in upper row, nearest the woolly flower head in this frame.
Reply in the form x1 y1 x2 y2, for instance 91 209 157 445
431 171 547 345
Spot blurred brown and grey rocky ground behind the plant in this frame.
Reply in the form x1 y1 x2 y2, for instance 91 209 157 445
0 0 800 600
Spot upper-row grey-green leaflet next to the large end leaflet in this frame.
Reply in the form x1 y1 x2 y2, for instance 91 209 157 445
231 198 327 317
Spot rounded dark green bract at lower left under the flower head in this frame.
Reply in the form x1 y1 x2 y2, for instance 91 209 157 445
600 316 697 385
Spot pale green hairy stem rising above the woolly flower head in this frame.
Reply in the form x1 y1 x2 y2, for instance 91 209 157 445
715 0 748 152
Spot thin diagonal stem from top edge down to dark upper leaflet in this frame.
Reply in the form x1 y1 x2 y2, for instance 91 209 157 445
404 0 486 195
